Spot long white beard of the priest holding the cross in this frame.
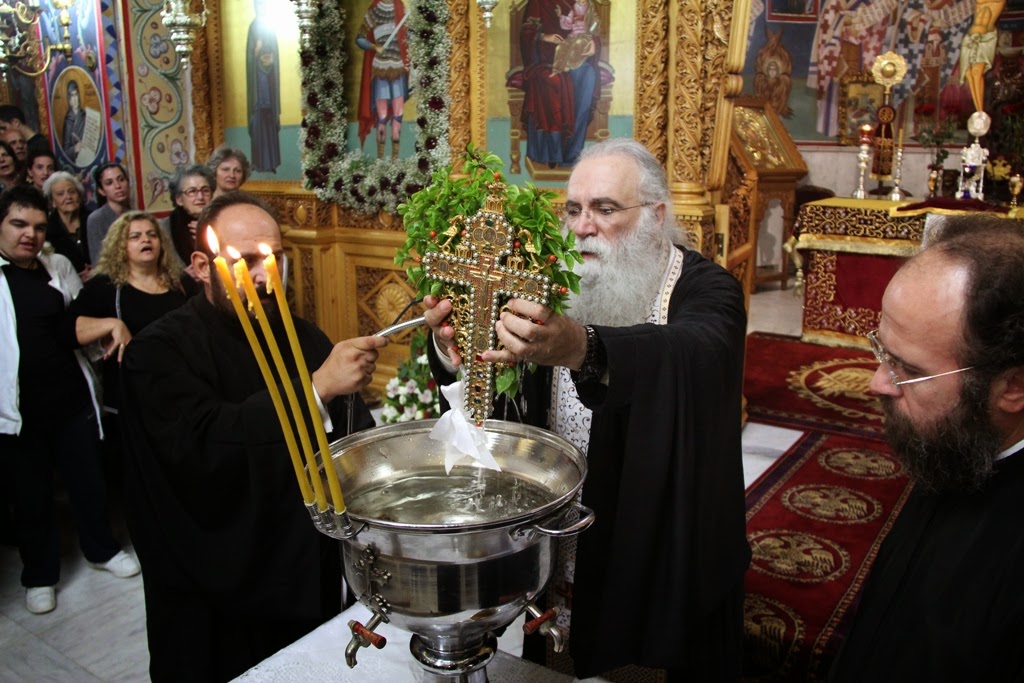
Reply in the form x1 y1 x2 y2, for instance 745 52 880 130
567 210 672 328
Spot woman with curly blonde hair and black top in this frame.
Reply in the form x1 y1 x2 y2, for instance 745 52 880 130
71 211 191 411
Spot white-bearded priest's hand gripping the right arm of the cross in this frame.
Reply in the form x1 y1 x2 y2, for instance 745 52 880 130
480 299 587 370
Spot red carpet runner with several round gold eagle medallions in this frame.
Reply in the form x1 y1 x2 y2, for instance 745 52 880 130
744 432 910 682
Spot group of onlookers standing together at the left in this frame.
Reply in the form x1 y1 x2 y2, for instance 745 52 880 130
0 104 268 626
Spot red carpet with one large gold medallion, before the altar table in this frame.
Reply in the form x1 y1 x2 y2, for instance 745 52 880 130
743 333 883 438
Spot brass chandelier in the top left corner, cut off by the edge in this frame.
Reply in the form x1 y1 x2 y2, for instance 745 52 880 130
0 0 75 78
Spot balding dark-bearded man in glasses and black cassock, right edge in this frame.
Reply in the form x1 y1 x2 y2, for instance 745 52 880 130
829 216 1024 682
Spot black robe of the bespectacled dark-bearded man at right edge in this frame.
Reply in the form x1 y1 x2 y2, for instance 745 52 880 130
829 452 1024 683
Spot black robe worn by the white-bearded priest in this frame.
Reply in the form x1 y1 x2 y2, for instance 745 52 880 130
428 246 751 681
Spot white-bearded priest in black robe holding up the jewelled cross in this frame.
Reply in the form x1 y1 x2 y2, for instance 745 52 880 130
426 139 750 681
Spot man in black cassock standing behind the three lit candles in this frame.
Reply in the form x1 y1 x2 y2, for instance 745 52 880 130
121 193 386 683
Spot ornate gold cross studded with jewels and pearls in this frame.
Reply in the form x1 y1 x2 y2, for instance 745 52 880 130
423 180 551 425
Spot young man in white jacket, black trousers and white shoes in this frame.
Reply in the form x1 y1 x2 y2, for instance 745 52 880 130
0 185 139 614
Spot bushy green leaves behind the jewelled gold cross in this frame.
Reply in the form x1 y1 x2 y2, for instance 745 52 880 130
394 145 583 409
